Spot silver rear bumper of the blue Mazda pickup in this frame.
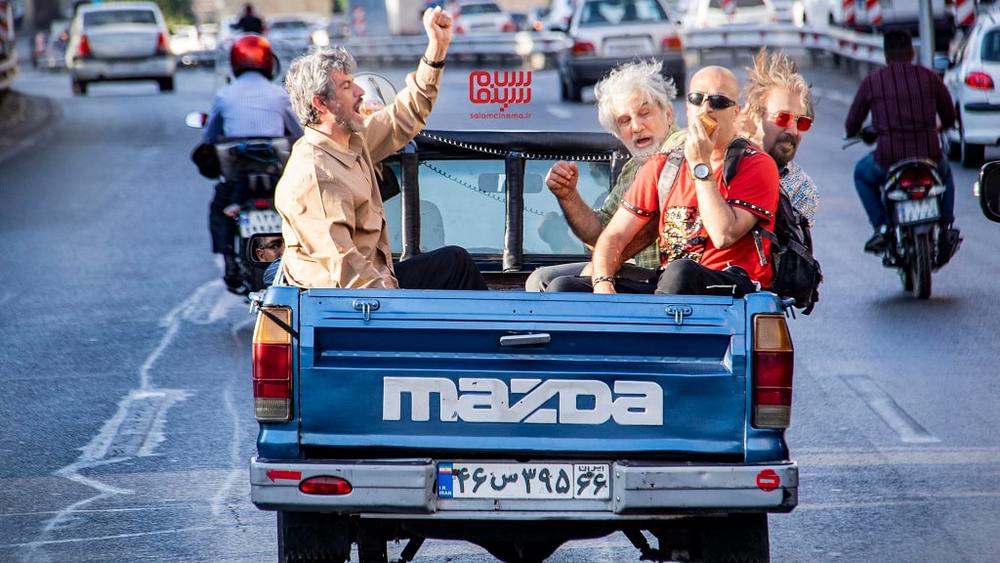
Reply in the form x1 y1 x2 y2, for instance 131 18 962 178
250 458 799 520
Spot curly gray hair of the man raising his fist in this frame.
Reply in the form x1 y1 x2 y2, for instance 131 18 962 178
285 47 357 125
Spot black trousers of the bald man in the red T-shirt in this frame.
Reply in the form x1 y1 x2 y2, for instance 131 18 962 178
546 259 757 297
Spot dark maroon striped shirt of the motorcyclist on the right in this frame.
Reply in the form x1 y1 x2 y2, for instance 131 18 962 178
844 62 955 169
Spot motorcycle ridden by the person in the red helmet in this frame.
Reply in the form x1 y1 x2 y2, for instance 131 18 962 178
185 112 291 295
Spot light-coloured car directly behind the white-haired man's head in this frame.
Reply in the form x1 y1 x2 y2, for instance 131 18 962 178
558 0 687 102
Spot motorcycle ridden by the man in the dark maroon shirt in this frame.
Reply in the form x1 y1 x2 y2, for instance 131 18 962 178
843 126 961 299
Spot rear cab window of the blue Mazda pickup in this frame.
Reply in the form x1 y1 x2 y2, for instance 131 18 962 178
385 160 611 256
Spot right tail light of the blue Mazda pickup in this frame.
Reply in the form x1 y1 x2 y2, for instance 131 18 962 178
751 314 795 428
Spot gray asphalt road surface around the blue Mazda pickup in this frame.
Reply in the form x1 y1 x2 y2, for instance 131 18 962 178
0 54 1000 563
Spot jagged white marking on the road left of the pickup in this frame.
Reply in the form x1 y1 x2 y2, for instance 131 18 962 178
24 280 235 561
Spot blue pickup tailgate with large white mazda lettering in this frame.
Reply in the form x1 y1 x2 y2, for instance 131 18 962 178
295 290 747 457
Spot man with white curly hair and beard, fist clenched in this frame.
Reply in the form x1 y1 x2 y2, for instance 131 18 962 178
525 60 684 291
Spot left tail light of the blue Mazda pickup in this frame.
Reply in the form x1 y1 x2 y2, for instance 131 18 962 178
253 307 292 422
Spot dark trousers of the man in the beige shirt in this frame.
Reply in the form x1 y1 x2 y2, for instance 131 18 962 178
394 246 487 289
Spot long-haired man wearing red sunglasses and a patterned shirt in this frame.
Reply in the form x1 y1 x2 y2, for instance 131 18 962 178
743 49 819 224
